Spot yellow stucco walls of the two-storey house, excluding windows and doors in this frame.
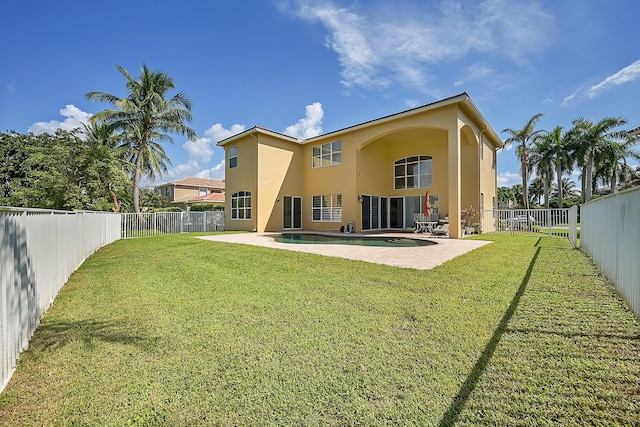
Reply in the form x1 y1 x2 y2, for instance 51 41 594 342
225 96 500 237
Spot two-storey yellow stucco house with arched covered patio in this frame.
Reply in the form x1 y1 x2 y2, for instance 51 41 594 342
218 93 502 238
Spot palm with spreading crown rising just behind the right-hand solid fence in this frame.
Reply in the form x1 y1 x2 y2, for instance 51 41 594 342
567 117 627 202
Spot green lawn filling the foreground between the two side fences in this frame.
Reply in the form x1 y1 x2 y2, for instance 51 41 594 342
0 235 640 426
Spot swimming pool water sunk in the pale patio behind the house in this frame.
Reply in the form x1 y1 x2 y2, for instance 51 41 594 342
273 233 436 248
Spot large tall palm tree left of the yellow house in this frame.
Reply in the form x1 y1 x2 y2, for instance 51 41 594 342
86 65 196 213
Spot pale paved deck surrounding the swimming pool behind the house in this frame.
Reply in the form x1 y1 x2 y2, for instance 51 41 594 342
198 230 491 270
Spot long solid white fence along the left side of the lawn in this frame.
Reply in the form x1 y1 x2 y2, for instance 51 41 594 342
0 207 120 391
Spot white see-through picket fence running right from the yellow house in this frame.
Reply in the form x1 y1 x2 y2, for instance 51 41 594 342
481 209 570 238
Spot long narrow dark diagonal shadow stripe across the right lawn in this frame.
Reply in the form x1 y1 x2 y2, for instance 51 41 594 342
438 246 541 427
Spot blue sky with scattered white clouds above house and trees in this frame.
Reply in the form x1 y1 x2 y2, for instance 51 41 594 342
0 0 640 186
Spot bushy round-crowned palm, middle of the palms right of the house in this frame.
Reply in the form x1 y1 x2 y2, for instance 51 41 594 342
531 126 572 209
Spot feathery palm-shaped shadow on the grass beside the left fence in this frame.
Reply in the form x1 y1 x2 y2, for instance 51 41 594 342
31 319 158 352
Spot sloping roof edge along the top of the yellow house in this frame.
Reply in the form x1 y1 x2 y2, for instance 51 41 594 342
216 92 504 148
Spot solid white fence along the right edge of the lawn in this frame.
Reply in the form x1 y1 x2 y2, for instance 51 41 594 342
580 187 640 318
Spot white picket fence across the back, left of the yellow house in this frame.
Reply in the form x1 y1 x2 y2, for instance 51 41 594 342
121 211 224 239
